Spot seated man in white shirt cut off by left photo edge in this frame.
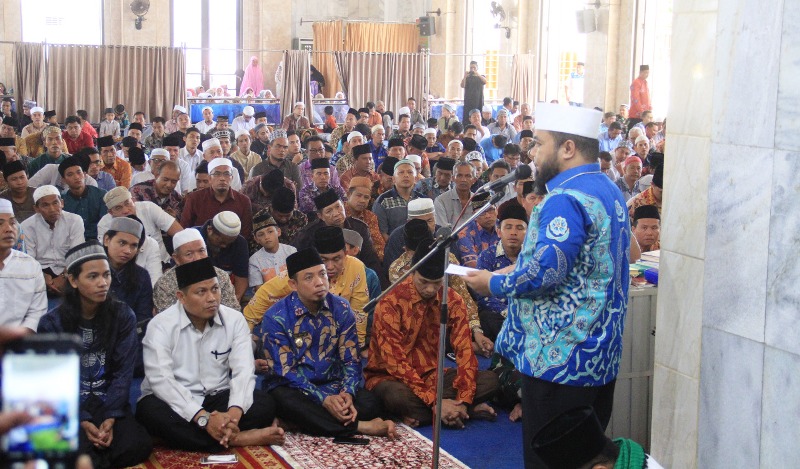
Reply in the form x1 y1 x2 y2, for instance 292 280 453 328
0 199 47 331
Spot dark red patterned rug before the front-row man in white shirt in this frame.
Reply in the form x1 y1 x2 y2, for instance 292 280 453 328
123 446 291 469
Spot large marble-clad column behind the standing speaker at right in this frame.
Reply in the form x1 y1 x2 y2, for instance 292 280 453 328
651 0 800 468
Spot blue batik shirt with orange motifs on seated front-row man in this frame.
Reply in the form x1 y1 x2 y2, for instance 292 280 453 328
260 292 361 404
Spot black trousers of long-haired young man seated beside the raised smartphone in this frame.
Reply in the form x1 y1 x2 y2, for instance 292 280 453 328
78 397 153 469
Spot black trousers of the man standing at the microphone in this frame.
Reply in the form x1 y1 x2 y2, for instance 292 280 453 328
522 375 617 469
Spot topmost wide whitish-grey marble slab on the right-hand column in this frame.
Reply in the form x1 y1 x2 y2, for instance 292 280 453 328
712 0 783 148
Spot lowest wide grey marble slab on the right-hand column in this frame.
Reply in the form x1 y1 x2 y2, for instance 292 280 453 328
696 327 764 468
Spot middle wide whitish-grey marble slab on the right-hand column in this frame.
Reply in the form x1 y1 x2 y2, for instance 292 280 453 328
703 143 774 342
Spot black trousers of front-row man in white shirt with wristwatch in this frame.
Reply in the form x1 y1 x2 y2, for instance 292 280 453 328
136 389 275 453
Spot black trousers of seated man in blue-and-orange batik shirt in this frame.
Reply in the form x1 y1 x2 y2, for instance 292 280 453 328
269 386 383 436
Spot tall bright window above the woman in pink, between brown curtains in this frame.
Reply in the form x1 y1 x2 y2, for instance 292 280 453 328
172 0 242 94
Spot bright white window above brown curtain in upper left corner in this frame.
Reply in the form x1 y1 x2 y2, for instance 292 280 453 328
20 0 103 45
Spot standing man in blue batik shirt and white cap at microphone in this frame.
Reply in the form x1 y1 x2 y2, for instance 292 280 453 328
465 104 630 469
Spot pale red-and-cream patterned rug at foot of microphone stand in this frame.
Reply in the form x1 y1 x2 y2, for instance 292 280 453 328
273 424 468 469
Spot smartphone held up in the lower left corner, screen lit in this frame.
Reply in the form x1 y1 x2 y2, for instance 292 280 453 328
0 334 81 462
